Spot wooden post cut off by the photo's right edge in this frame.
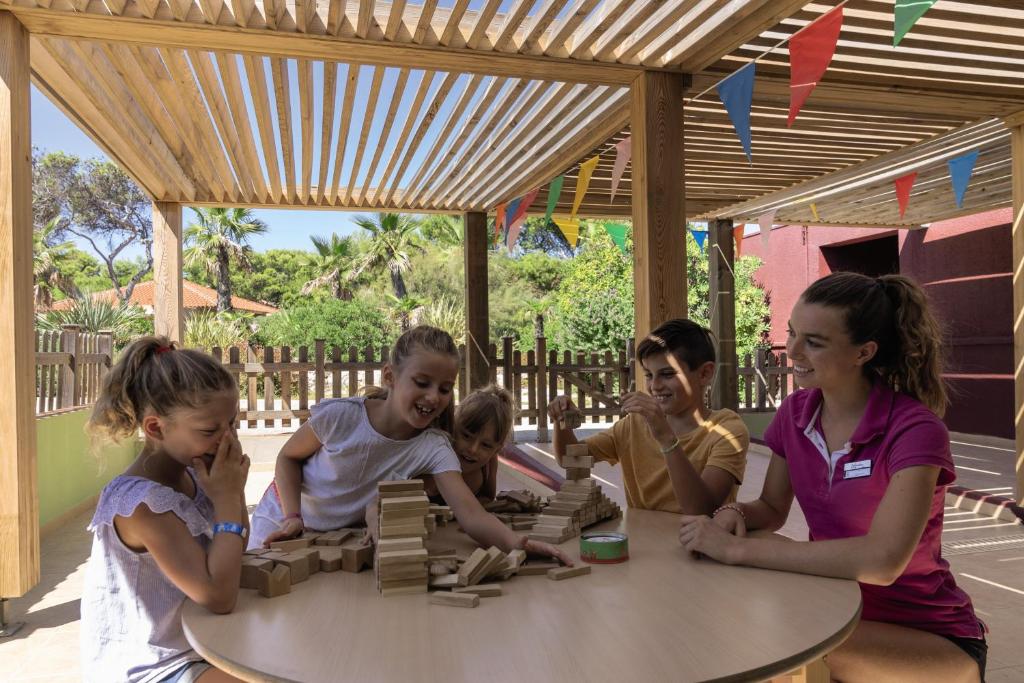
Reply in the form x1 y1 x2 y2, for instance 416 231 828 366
1007 112 1024 504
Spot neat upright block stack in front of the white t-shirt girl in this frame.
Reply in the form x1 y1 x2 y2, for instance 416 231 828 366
374 479 436 596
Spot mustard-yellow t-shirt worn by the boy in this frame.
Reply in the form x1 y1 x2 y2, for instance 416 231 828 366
585 409 751 513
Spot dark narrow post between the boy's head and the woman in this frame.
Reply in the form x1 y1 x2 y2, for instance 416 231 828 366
708 220 739 411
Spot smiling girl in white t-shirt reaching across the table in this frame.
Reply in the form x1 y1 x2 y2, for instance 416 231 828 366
249 326 570 563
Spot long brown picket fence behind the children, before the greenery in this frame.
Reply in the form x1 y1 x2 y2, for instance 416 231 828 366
205 337 792 440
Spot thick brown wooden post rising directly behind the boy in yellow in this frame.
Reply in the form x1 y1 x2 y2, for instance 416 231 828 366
630 72 689 389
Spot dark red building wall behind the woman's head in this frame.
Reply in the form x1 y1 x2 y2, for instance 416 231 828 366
742 209 1014 438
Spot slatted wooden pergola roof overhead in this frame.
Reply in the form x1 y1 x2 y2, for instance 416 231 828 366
8 0 1024 223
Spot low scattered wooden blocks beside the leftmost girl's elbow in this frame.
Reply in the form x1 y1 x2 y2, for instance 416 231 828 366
241 529 374 598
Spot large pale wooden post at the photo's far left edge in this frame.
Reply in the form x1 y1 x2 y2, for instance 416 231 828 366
0 11 39 598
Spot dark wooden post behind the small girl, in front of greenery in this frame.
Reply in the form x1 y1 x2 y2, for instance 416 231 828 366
463 211 490 391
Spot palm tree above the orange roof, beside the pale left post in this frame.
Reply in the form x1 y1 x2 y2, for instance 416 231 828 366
185 208 267 312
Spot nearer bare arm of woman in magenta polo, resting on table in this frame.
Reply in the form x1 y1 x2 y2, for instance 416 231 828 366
680 465 939 586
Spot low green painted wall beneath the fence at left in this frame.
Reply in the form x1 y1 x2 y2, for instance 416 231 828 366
36 409 142 527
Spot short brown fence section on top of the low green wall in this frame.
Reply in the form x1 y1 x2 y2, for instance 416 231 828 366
36 325 114 415
